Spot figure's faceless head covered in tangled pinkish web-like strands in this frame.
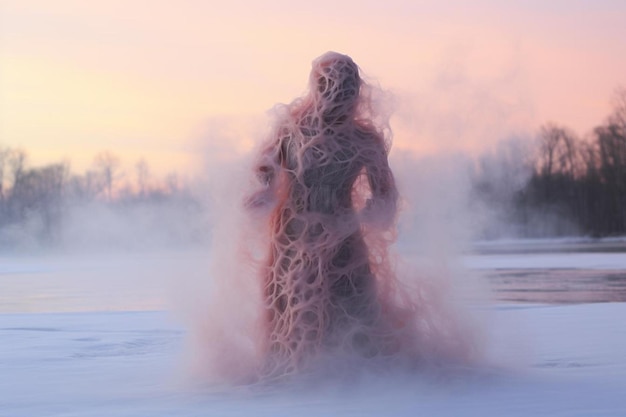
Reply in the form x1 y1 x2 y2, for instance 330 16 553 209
310 52 361 122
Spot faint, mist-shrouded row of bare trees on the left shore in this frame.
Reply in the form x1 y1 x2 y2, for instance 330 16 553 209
0 146 204 249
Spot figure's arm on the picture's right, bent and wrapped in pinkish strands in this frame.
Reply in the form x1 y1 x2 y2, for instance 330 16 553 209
361 133 398 228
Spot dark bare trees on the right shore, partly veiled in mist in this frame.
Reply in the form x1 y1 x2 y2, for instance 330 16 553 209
474 88 626 237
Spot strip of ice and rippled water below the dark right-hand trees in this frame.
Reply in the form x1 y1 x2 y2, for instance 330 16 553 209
463 239 626 303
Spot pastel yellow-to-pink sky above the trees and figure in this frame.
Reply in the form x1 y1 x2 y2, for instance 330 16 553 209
0 0 626 173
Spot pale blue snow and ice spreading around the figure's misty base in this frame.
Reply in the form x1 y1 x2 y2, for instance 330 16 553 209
0 242 626 417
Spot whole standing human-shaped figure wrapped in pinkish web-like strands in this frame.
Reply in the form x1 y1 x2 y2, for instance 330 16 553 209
243 53 420 376
